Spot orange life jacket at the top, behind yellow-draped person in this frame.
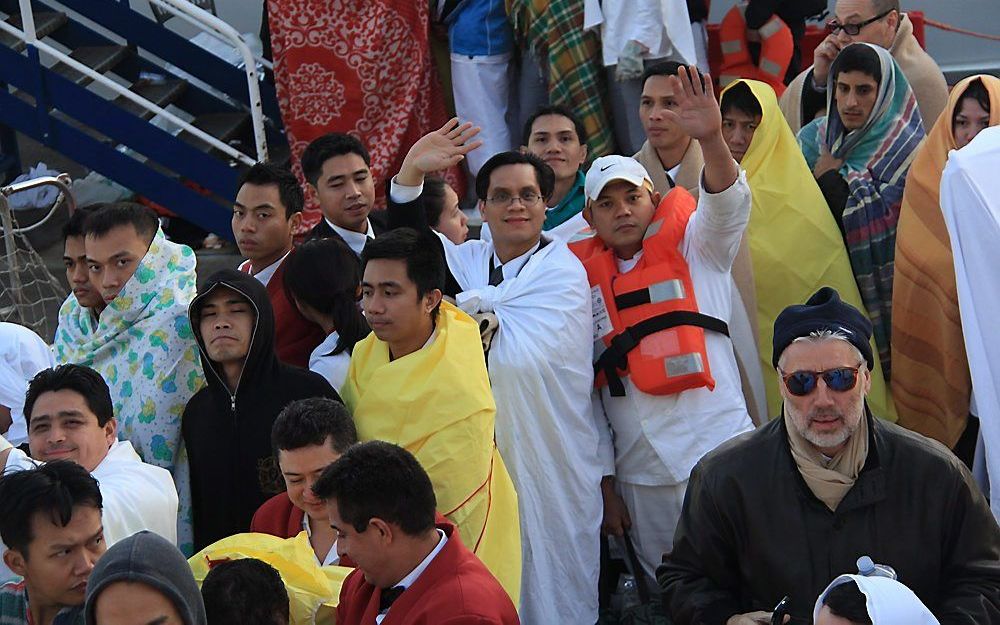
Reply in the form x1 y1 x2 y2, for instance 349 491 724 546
719 4 795 98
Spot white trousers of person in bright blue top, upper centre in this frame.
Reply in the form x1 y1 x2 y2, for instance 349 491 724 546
451 53 513 177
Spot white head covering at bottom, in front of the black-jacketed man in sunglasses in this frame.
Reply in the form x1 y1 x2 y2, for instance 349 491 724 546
813 556 940 625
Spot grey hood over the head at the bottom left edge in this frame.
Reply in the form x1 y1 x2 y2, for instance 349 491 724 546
84 531 208 625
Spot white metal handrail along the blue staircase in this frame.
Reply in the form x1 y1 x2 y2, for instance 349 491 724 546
0 0 267 165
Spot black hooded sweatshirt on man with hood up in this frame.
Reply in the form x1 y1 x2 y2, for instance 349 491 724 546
181 269 340 550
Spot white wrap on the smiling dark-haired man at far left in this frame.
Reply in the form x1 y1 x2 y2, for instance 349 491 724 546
0 438 177 580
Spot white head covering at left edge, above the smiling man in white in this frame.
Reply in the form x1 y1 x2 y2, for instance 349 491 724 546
0 322 55 445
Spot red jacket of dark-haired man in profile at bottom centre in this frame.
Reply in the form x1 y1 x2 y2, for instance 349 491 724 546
337 521 520 625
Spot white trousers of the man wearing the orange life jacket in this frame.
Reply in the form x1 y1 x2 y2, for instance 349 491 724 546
615 480 688 580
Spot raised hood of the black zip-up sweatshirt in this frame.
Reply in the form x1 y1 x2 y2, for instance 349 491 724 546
188 269 278 395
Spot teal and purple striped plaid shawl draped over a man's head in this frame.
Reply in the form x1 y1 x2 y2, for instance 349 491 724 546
799 44 924 379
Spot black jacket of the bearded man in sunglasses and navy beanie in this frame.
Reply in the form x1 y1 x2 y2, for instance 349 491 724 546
657 416 1000 625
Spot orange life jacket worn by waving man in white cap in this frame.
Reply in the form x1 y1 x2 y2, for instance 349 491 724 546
570 187 729 397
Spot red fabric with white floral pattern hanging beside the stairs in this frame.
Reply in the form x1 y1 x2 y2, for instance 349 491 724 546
267 0 464 233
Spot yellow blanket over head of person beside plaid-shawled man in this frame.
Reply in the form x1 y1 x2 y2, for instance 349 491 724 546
723 80 896 421
